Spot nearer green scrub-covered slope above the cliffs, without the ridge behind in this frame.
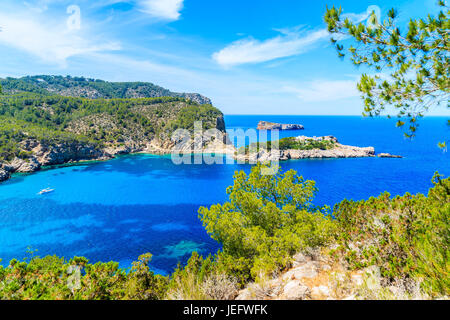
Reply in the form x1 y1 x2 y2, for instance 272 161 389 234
0 92 222 161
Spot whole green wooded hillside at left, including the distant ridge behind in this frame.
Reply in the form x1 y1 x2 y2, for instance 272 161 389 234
0 76 223 162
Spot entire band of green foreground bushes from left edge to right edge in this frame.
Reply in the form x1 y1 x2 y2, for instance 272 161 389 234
0 164 450 299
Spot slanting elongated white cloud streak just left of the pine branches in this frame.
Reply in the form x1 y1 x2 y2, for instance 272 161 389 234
213 29 328 67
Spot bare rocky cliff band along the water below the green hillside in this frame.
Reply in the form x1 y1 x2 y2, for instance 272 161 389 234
0 117 232 182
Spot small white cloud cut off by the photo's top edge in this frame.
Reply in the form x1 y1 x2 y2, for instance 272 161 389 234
138 0 183 20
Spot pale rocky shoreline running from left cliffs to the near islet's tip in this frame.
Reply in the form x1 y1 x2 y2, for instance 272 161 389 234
0 133 401 182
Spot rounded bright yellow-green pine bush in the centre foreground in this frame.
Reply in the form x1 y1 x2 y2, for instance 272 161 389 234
199 165 335 280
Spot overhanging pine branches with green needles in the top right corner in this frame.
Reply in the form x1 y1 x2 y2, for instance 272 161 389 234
324 1 450 147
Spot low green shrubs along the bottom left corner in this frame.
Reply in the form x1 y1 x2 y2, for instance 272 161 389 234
0 254 168 300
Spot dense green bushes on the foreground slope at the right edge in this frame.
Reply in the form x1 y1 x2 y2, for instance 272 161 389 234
334 174 450 295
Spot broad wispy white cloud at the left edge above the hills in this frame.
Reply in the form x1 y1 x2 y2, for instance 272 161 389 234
0 12 120 66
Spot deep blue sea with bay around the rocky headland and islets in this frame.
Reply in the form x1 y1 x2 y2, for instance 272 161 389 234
0 115 450 274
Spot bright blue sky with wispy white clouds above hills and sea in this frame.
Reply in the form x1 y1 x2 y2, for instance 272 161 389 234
0 0 449 115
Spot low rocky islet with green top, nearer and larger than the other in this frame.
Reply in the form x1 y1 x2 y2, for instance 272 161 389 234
235 136 401 163
